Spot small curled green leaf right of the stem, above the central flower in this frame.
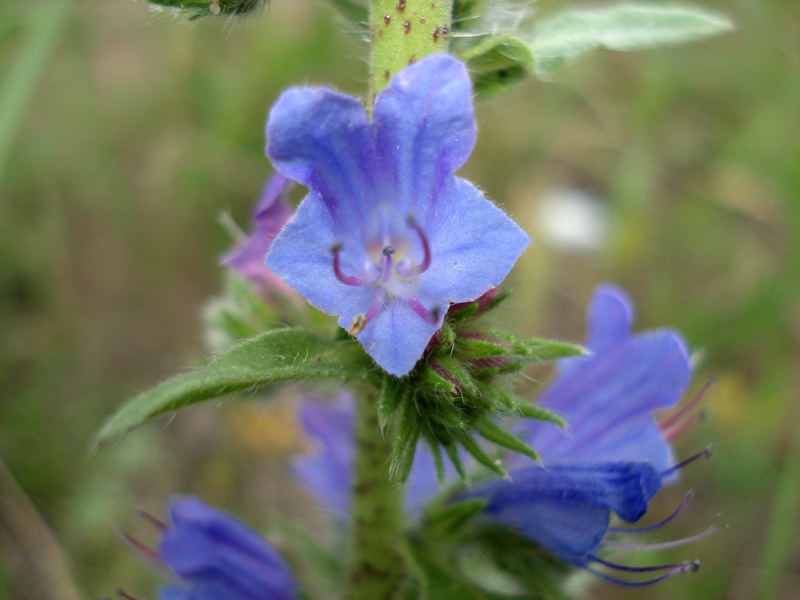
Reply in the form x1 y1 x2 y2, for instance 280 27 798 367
459 33 535 98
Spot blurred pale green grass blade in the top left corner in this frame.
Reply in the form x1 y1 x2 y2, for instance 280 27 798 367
0 0 72 181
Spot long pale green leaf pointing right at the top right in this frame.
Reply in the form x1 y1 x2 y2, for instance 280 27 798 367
530 4 733 79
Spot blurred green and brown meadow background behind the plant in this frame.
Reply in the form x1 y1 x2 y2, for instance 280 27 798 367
0 0 800 600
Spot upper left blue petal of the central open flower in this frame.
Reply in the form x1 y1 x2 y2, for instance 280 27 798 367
267 88 379 241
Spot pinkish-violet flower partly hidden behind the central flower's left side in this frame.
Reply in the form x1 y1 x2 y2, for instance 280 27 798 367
222 173 295 297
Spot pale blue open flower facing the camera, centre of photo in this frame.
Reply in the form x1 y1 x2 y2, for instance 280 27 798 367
267 54 530 376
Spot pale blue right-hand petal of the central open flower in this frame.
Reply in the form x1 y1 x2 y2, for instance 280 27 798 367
418 177 530 307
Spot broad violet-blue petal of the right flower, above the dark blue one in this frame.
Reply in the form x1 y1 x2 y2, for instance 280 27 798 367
524 330 691 471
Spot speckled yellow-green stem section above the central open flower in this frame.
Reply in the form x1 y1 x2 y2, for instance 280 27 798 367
369 0 453 99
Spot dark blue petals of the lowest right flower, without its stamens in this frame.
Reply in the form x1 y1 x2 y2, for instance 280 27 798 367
469 462 660 566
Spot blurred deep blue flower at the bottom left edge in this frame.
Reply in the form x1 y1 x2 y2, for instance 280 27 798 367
158 497 298 600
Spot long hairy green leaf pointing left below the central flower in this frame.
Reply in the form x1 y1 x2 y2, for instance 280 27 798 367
95 329 371 446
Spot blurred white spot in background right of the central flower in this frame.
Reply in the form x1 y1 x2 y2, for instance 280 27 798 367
537 187 608 252
